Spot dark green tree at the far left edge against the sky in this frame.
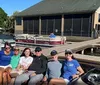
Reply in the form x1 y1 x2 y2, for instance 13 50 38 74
0 7 7 28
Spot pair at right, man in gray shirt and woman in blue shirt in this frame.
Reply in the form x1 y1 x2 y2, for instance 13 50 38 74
43 49 84 85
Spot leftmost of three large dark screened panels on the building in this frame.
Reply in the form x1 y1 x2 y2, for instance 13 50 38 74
23 17 39 34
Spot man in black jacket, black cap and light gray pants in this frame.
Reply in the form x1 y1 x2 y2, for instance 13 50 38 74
15 47 47 85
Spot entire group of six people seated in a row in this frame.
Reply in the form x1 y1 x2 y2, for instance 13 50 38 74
0 42 84 85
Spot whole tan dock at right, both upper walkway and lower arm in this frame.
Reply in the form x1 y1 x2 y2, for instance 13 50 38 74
17 38 100 67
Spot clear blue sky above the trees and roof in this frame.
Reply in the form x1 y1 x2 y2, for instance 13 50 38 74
0 0 42 16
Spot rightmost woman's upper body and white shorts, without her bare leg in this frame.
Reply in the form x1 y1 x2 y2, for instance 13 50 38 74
62 49 84 83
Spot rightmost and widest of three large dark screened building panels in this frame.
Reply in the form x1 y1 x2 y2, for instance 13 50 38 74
64 13 92 37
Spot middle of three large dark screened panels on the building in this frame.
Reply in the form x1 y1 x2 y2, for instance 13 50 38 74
41 15 62 35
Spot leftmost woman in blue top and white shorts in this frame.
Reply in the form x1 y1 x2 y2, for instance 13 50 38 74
0 42 13 85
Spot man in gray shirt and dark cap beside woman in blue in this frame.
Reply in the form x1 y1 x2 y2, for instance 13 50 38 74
43 50 62 81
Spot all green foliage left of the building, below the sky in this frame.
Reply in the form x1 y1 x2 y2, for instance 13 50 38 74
0 8 14 33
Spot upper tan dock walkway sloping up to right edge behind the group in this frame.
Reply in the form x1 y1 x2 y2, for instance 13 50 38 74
43 38 100 56
